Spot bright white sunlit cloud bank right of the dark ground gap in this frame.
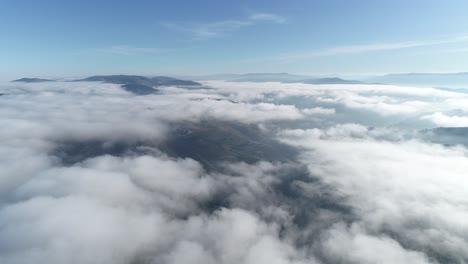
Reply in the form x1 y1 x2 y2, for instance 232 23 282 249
283 125 468 263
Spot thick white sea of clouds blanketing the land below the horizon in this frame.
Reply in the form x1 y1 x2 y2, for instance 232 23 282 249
0 79 468 264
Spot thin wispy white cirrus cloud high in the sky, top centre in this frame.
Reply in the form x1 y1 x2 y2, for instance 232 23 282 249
163 13 286 39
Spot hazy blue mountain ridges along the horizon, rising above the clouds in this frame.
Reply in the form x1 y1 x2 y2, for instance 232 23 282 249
14 72 468 89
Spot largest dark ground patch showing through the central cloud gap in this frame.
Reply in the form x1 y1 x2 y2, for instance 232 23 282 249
51 120 298 171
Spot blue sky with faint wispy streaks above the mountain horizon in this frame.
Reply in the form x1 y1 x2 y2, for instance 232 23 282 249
0 0 468 78
